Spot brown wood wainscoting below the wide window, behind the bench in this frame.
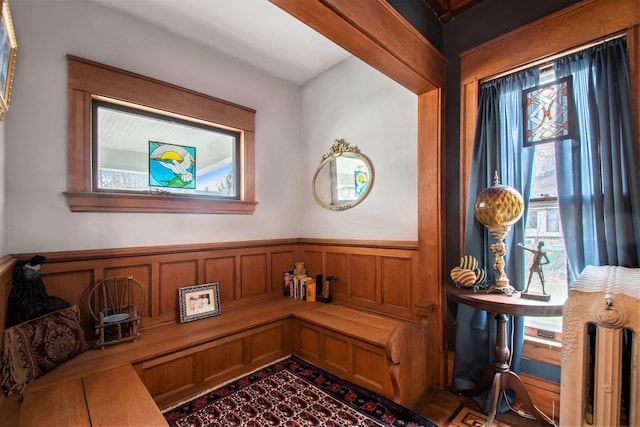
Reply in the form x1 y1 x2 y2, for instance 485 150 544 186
9 239 299 330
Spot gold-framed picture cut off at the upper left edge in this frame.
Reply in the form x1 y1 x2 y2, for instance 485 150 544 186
0 0 18 120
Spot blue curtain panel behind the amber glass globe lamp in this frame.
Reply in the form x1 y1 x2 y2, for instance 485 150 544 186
452 69 539 412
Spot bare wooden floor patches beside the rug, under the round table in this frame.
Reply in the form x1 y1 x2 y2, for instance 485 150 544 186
414 388 542 427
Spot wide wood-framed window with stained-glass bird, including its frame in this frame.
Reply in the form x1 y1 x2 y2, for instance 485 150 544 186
64 56 256 214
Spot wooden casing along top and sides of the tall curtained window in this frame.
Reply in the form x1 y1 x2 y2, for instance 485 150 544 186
460 0 640 247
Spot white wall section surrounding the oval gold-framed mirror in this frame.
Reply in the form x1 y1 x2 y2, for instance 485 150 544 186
300 57 418 240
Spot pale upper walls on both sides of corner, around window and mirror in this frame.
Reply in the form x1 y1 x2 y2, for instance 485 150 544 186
5 0 417 253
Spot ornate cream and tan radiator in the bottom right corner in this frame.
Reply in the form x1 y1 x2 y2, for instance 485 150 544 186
560 266 640 427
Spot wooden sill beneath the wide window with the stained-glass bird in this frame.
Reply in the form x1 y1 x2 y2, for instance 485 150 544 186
63 192 258 215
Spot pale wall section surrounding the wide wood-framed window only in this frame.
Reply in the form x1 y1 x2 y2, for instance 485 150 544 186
5 0 301 253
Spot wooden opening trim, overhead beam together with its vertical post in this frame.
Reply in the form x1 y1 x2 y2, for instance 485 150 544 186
270 0 446 384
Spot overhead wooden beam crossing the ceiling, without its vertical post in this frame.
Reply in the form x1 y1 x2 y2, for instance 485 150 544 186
270 0 446 94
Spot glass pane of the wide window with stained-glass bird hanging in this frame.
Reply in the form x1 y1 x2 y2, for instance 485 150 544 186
93 101 240 199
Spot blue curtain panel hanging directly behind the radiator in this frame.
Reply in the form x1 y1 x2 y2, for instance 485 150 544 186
554 38 640 280
